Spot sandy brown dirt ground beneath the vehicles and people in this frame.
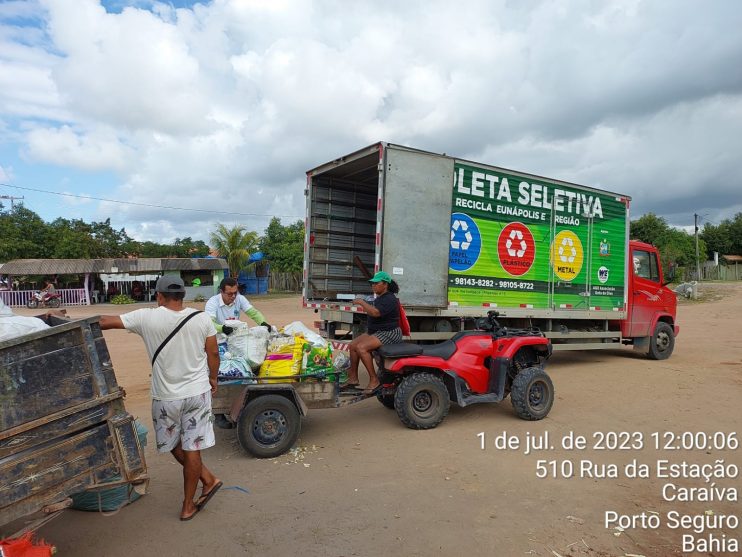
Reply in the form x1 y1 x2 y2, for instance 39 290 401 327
5 285 742 557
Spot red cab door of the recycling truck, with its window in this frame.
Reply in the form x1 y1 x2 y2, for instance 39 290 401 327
628 248 662 337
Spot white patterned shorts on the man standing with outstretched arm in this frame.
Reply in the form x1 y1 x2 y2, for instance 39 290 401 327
152 391 216 453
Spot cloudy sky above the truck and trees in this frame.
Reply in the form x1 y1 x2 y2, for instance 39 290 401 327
0 0 742 241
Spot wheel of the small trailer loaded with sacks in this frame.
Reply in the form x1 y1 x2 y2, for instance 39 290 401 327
237 395 301 458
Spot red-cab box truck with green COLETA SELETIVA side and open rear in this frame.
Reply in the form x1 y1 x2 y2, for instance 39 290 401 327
303 142 678 358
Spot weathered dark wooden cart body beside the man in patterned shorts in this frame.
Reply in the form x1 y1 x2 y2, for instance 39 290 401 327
0 317 148 525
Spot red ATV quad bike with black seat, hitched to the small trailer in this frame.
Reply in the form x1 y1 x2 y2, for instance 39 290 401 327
376 311 554 429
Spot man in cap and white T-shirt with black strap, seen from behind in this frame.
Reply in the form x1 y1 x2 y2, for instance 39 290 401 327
100 277 222 520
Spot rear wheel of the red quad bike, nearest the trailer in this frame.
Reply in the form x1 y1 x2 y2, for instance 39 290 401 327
394 372 451 429
